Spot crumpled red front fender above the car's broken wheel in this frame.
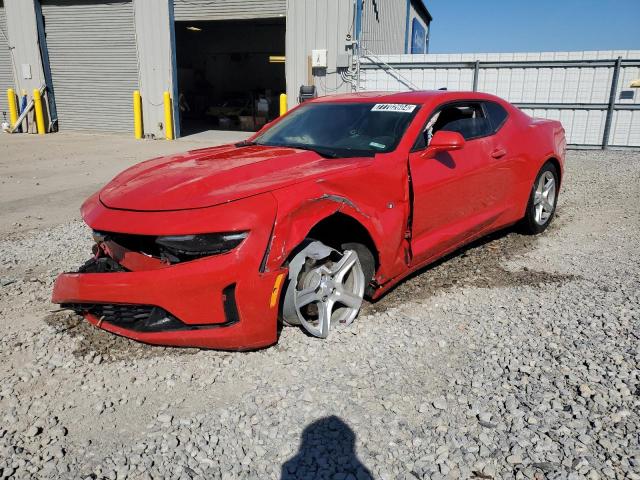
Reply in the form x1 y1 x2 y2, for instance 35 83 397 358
262 153 409 284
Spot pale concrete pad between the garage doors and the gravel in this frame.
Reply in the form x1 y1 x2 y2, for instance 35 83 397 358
0 131 250 236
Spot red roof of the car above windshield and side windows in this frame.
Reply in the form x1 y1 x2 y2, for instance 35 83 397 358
313 90 504 104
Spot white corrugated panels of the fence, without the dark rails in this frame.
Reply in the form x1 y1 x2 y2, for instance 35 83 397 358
361 50 640 146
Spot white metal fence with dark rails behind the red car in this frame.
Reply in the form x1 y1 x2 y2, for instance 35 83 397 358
360 50 640 148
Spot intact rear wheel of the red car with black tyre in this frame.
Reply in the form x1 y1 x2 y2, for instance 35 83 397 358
522 162 559 235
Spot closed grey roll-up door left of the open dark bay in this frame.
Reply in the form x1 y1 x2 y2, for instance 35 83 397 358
42 0 138 132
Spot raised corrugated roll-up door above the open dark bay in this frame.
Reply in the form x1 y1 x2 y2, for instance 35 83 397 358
173 0 287 21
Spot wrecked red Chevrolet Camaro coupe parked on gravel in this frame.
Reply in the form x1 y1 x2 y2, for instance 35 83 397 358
53 91 566 350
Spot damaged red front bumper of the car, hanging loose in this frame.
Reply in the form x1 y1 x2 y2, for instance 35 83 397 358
52 193 285 350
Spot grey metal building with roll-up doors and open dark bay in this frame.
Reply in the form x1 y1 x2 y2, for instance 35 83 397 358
0 0 431 138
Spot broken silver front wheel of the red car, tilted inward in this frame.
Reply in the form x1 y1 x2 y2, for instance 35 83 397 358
282 240 373 338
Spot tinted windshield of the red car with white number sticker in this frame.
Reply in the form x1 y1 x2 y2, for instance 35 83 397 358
255 103 419 157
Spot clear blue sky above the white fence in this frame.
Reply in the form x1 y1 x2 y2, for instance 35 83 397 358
425 0 640 53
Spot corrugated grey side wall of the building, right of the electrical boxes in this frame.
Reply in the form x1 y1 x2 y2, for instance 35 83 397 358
362 0 407 55
